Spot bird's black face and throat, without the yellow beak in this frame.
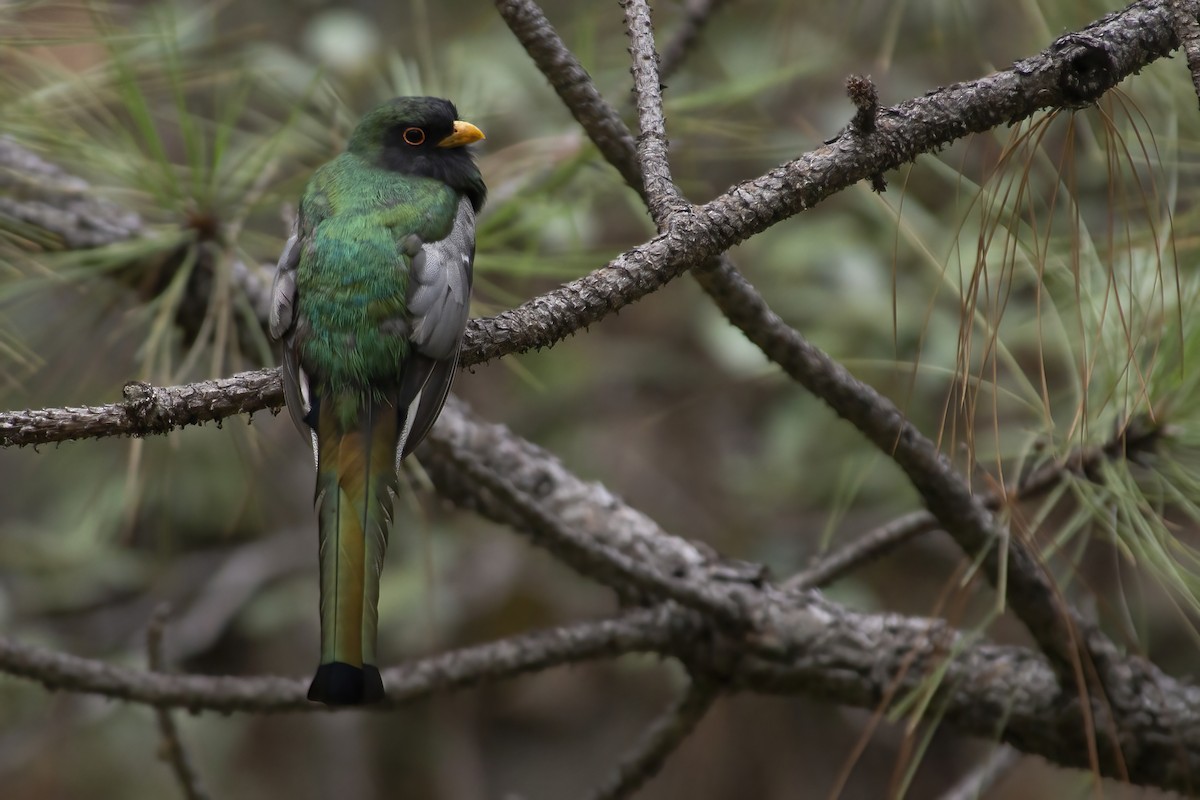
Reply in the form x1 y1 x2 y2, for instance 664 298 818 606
380 97 485 211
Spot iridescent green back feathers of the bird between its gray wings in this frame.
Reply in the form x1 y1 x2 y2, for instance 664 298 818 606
296 154 457 395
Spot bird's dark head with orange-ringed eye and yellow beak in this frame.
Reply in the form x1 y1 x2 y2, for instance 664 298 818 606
347 97 487 211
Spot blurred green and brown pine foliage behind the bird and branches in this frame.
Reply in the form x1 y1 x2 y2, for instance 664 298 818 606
0 0 1200 800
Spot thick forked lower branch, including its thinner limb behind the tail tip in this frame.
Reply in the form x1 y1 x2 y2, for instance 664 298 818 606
0 381 1200 787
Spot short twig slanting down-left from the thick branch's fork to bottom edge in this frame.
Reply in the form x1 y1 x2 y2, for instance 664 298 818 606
588 679 720 800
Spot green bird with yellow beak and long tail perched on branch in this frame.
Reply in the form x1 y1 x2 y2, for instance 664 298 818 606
270 97 487 705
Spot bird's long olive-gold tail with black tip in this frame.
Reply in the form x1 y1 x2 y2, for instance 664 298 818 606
308 396 401 705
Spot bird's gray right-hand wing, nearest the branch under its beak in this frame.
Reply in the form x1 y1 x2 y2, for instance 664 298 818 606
398 198 475 458
